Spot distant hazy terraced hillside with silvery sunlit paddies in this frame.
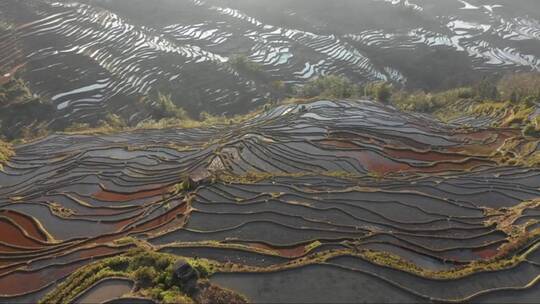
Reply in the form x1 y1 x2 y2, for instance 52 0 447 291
0 0 540 135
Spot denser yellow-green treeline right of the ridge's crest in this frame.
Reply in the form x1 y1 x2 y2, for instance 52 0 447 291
287 73 540 136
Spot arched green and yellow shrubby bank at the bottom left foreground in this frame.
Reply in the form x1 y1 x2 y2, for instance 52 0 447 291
40 248 247 303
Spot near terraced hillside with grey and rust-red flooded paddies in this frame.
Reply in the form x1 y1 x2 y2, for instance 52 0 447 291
0 100 540 303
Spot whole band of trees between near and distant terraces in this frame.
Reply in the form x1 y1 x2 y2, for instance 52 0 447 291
0 70 540 144
